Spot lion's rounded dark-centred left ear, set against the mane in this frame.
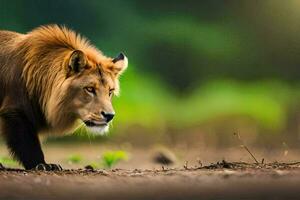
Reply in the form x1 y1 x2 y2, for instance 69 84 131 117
68 50 87 73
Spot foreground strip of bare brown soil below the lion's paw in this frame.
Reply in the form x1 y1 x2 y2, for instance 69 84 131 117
0 161 300 200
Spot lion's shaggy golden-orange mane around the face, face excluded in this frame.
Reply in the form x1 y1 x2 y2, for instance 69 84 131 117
0 25 126 132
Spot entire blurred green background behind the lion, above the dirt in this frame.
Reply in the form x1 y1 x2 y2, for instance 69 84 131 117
0 0 300 146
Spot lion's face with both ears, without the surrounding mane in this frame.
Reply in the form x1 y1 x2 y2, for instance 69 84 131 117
65 50 128 134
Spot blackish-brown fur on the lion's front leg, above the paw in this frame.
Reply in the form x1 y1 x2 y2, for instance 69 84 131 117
0 109 45 169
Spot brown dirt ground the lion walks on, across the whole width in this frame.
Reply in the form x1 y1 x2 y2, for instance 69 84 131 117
0 144 300 200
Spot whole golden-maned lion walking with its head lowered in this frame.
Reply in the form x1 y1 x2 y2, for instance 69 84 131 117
0 25 128 170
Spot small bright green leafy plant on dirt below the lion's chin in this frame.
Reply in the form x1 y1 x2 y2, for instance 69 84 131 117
101 151 128 169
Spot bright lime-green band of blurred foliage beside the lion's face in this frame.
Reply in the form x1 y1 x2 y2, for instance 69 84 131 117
115 67 300 131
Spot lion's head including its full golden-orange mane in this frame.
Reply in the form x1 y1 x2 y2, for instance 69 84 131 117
19 25 128 134
